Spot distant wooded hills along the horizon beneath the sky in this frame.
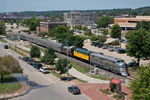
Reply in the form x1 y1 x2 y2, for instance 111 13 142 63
1 6 150 17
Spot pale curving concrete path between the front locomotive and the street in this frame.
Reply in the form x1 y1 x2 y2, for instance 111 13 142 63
69 67 109 83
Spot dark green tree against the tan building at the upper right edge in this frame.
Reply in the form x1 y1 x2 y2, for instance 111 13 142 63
136 21 150 31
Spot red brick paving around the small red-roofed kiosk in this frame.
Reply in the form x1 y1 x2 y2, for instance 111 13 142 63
76 83 132 100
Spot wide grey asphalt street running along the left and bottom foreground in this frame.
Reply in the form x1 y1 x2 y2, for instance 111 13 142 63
0 43 91 100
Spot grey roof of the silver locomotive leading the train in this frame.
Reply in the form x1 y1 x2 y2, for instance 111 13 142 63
91 53 122 62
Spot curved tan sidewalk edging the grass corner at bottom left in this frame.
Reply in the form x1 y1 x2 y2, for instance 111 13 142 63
0 82 30 100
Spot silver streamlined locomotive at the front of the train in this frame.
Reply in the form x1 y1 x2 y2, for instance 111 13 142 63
90 53 128 76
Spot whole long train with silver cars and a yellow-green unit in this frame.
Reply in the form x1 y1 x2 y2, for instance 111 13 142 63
18 34 128 76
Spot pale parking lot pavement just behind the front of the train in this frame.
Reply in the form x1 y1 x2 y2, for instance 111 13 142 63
83 42 150 65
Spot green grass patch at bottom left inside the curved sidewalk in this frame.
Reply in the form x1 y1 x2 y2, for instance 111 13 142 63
0 83 21 94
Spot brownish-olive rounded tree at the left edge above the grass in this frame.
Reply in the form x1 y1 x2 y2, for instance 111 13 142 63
0 55 22 82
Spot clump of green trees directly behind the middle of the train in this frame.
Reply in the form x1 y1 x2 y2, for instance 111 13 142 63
50 25 85 48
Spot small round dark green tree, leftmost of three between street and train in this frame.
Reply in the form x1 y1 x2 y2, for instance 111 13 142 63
30 46 41 58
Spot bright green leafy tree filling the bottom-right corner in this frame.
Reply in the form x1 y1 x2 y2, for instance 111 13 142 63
130 65 150 100
